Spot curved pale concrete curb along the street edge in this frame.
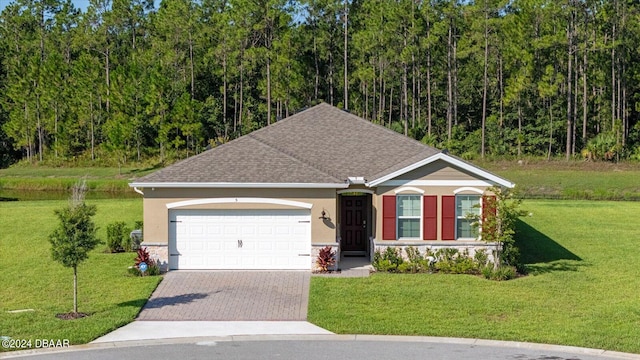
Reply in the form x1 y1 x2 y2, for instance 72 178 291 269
0 335 640 360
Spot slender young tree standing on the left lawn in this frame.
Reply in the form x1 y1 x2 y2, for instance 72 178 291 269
49 181 100 317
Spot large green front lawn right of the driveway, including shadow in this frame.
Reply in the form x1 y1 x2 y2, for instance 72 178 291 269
308 200 640 353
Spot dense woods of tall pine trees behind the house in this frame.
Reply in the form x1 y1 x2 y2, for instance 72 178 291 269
0 0 640 166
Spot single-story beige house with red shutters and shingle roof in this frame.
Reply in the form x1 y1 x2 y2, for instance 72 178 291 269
129 103 514 270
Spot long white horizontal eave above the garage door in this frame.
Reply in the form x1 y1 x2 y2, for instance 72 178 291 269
129 182 349 189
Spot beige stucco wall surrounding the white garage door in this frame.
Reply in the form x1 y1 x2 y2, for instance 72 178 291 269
143 188 337 244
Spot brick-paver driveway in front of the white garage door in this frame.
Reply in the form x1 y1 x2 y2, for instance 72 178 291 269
138 270 310 321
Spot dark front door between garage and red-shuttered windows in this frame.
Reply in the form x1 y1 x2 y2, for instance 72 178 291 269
340 195 370 256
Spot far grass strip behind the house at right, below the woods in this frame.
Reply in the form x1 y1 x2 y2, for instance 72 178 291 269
478 160 640 200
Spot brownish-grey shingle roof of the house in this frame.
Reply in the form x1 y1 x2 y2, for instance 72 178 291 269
135 103 439 184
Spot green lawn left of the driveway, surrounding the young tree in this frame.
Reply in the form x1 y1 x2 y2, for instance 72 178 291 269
0 199 160 344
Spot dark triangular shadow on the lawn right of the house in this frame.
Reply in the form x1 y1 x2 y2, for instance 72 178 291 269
516 220 585 274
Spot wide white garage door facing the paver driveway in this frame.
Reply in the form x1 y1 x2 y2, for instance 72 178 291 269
169 210 311 270
